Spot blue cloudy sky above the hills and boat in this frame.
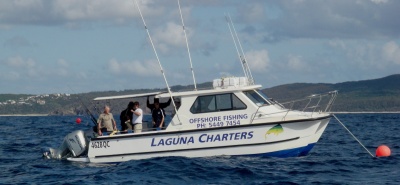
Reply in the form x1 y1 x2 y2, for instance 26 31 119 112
0 0 400 94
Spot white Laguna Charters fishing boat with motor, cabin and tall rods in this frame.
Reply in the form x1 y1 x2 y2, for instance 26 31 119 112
45 1 338 163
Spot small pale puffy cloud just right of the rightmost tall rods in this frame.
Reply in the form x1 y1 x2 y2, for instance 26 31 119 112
246 49 270 72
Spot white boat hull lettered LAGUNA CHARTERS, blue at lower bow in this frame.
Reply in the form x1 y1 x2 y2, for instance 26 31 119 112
68 116 330 163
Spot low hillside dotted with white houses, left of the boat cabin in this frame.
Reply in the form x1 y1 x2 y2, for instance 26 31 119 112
0 82 212 115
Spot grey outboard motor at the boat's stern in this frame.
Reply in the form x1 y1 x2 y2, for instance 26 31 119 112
43 130 89 159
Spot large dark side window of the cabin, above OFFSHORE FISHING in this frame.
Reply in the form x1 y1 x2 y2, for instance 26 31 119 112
190 93 247 114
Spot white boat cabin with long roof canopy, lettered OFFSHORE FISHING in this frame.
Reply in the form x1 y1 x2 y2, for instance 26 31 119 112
94 77 334 132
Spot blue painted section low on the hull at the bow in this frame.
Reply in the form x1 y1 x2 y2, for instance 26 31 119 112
247 143 315 158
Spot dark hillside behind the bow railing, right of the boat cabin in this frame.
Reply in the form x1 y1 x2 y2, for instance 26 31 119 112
263 74 400 112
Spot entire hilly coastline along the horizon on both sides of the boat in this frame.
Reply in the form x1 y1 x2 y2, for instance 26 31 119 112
0 74 400 115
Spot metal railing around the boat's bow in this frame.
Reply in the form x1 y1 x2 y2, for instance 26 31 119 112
250 90 338 123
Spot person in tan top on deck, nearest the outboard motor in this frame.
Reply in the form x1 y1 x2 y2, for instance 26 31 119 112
97 105 117 136
